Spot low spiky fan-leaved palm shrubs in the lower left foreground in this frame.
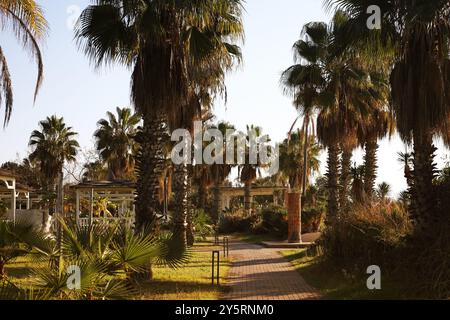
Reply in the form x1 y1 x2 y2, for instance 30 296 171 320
0 221 189 300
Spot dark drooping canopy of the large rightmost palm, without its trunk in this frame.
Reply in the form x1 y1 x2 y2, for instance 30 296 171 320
325 0 450 143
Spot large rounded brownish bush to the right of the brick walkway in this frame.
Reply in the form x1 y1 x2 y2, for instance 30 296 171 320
321 203 412 273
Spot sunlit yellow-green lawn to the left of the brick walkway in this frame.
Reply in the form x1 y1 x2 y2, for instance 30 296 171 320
6 242 230 300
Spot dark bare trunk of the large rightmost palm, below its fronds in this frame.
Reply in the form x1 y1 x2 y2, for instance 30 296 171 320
411 132 439 234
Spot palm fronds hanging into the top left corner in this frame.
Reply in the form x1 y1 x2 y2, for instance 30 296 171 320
0 0 47 125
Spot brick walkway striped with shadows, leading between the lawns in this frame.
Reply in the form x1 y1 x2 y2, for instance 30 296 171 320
223 242 320 300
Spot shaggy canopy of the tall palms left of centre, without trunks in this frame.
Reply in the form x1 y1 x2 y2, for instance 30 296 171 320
76 0 243 129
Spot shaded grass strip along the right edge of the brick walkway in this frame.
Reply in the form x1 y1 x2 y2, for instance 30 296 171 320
280 249 417 300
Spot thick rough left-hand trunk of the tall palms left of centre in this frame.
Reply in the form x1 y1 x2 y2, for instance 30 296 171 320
135 115 167 232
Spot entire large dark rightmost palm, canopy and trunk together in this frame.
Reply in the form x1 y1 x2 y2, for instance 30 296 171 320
325 0 450 234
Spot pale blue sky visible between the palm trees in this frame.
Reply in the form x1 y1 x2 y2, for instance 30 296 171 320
0 0 442 193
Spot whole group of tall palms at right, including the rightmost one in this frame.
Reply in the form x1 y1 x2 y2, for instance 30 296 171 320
282 0 450 238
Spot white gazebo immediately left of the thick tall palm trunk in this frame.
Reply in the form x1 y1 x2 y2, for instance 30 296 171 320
71 180 136 227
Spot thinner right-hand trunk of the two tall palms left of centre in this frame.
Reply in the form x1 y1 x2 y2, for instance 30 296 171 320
173 164 189 246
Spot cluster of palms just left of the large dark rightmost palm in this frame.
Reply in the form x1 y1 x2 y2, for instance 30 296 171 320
282 11 392 220
